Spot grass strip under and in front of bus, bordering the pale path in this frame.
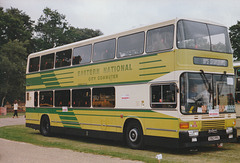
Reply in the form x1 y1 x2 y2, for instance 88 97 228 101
0 125 240 163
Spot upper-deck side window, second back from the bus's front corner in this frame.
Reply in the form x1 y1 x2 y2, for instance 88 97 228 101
117 32 144 58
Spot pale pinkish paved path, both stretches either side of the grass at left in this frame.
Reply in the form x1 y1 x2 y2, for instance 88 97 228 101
0 116 142 163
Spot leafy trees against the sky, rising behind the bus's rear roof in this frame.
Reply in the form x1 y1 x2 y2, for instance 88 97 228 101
34 8 102 51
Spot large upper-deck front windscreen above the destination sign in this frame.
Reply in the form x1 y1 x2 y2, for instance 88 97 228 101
177 20 232 53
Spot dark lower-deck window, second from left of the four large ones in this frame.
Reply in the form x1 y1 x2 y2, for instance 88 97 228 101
55 90 70 107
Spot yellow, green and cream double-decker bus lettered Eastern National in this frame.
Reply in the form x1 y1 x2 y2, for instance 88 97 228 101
26 19 236 149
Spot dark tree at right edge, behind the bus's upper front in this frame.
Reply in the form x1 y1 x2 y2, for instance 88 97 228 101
229 21 240 60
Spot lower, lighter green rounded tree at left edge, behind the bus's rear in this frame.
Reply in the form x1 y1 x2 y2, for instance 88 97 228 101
0 40 27 106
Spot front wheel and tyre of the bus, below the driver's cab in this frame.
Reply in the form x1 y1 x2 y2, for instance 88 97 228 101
125 121 143 149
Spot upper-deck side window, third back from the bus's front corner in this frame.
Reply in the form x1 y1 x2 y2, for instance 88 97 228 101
93 39 116 61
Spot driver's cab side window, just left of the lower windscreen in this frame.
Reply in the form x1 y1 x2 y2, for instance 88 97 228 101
151 84 176 108
